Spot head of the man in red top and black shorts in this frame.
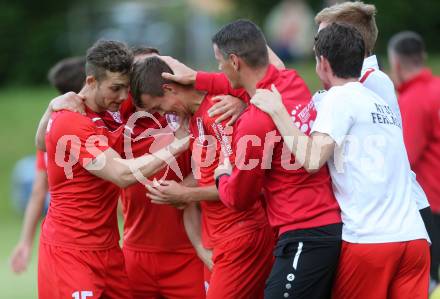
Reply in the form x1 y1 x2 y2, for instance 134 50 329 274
212 20 269 88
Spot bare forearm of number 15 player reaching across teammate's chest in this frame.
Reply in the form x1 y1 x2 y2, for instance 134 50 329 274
84 136 190 188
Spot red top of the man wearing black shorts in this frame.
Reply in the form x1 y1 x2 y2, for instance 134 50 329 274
196 65 341 234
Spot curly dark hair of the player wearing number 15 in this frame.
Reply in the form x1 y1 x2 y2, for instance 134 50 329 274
86 40 133 81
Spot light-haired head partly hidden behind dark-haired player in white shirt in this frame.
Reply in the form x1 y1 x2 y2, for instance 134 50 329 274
315 1 379 56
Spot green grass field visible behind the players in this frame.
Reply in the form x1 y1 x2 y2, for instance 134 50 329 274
0 59 440 299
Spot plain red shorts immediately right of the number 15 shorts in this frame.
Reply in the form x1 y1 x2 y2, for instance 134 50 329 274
123 248 205 299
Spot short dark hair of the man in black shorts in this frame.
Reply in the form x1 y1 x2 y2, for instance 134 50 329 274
212 20 269 68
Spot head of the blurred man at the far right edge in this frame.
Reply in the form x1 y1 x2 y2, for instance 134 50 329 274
388 31 426 84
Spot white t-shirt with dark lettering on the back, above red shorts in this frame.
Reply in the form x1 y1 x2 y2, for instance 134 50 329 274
312 82 429 243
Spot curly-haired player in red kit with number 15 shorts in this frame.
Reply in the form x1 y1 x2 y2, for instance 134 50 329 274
37 41 188 298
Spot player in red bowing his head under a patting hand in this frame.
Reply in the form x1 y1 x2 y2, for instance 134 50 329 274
131 57 273 298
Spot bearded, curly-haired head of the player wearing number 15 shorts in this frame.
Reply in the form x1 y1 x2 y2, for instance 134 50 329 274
86 40 133 111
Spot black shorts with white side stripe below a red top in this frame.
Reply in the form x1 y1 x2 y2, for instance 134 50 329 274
264 223 342 299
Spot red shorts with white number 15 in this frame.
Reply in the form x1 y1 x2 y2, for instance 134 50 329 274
38 242 133 299
